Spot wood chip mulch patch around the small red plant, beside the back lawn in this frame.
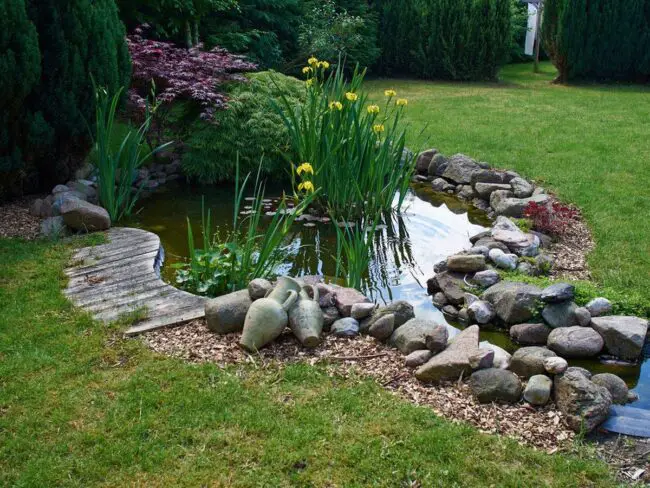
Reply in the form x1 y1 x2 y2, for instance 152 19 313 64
550 208 595 280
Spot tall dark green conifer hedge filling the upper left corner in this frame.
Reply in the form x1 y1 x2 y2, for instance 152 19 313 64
0 0 131 198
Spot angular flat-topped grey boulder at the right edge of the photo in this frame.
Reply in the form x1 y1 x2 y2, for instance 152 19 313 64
591 315 648 360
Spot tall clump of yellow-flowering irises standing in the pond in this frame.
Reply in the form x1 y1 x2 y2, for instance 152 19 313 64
276 57 415 220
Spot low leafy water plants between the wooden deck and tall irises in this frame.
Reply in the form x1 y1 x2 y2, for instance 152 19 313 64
174 156 313 296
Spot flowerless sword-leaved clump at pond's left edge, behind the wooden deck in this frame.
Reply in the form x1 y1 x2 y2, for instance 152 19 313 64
94 87 171 222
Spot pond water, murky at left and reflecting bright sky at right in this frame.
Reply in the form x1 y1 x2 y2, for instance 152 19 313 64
128 183 650 409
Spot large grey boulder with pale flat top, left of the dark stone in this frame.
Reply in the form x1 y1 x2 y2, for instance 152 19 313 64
483 281 542 324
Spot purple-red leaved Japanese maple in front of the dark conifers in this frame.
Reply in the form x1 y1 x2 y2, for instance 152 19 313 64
127 25 257 120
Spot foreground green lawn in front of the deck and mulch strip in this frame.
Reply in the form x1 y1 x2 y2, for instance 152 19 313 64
0 236 614 487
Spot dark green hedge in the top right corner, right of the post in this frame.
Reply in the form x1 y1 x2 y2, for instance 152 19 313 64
543 0 650 82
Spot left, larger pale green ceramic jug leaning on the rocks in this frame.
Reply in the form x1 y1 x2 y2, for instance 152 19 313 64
239 276 300 351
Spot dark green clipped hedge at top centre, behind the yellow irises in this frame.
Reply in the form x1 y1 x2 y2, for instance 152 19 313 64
377 0 511 80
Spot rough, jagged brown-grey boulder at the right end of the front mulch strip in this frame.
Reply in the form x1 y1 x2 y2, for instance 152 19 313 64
553 370 612 433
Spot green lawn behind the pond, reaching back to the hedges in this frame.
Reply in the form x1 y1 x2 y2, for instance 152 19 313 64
367 63 650 301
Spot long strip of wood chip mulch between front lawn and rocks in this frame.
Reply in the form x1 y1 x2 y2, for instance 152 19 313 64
142 320 575 453
